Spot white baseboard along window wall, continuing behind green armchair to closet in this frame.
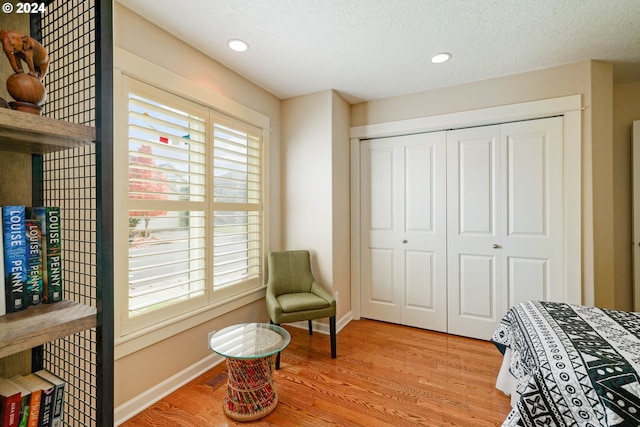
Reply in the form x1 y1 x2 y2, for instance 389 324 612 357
113 312 352 426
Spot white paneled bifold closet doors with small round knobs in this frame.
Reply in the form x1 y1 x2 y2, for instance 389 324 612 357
359 117 565 339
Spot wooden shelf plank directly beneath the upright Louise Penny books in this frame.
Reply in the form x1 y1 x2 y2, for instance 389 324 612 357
0 300 97 358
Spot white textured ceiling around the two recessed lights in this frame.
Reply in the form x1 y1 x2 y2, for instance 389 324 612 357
118 0 640 103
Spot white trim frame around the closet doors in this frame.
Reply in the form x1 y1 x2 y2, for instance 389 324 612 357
350 95 594 319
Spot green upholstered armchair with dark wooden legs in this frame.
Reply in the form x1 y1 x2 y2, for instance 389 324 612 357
266 250 336 369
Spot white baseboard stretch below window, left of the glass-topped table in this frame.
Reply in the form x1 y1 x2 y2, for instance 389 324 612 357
113 353 224 426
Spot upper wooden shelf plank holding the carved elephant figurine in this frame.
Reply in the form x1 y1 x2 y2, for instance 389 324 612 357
0 108 96 154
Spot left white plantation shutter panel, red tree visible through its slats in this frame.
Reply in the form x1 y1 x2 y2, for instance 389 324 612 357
129 88 207 317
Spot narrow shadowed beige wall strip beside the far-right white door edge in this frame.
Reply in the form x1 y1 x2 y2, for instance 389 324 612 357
613 81 640 310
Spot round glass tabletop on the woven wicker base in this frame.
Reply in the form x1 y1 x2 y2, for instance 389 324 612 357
209 323 291 359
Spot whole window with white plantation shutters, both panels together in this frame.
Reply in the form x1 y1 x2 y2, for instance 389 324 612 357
123 78 264 332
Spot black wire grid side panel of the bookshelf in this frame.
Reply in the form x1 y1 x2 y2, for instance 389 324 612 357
40 0 97 426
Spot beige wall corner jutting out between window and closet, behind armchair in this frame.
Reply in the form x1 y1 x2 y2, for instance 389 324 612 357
282 90 351 319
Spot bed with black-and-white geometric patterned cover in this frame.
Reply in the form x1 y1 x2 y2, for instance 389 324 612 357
491 301 640 427
